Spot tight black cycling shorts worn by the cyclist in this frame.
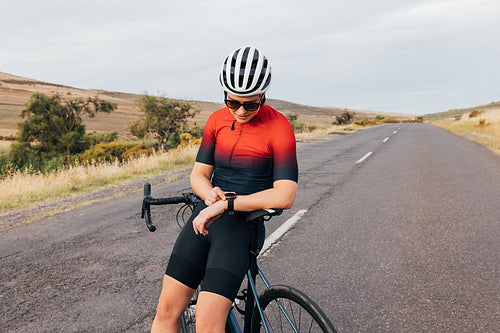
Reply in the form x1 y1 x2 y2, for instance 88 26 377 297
165 202 265 301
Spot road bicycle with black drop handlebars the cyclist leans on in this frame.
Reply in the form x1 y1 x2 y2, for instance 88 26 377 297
141 183 336 333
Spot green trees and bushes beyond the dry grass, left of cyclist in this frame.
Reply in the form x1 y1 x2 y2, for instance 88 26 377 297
0 93 203 177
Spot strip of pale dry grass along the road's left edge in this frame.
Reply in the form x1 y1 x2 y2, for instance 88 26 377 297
0 146 198 210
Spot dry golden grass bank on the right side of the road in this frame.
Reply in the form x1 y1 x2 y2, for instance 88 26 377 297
432 109 500 155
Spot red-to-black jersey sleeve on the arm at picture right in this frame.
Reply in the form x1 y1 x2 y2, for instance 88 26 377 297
270 116 299 182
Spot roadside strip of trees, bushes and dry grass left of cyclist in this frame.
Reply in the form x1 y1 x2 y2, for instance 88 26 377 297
0 93 203 209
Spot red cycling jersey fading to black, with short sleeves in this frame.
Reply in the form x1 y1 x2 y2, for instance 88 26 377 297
196 104 298 195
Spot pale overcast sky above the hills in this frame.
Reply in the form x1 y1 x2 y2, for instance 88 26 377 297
0 0 500 115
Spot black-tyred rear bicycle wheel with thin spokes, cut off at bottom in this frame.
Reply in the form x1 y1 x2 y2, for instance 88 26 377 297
252 285 336 333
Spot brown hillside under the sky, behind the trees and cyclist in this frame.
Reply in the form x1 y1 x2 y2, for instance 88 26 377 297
0 72 413 137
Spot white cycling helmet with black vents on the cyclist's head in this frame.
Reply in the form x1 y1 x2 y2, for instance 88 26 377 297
219 46 271 96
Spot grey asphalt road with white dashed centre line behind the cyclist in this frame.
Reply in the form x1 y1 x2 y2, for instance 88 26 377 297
0 124 500 332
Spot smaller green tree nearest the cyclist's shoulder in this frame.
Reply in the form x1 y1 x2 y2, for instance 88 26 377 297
130 95 199 149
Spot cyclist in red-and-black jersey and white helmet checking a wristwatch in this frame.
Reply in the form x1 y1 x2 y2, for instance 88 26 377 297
152 47 298 332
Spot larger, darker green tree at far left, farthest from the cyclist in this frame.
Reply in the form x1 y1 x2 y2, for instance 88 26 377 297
16 93 116 162
